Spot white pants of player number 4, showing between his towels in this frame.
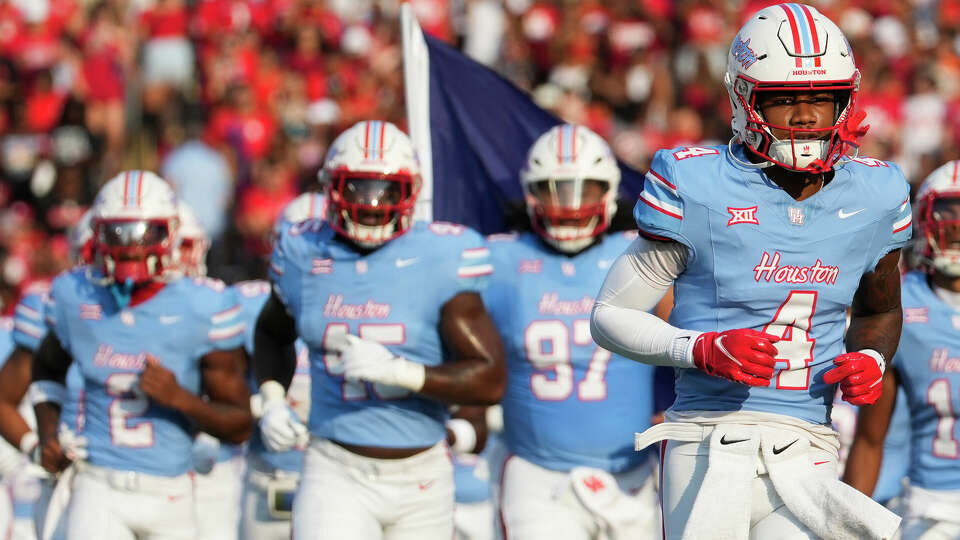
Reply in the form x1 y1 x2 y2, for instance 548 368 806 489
660 438 838 540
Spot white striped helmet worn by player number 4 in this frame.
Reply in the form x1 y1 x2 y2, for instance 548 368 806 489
725 4 861 172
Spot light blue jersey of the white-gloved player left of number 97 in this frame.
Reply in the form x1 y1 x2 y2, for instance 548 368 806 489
270 220 492 448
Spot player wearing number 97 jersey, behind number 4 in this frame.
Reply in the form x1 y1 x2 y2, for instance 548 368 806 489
484 124 659 539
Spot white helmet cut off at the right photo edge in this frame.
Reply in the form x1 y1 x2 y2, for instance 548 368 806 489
914 161 960 277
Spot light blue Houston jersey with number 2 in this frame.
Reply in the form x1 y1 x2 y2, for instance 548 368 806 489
46 268 244 476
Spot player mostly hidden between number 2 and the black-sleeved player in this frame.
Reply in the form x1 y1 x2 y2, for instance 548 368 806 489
234 192 325 540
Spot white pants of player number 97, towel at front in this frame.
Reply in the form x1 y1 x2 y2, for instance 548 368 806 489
499 456 660 540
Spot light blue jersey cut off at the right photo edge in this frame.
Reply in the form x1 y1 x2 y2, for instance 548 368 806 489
893 272 960 490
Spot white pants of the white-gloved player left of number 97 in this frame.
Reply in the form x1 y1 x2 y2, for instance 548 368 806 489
293 438 454 540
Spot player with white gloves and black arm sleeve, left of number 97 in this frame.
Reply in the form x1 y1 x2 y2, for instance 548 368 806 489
254 121 505 539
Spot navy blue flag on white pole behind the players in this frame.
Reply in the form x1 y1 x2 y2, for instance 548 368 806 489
404 8 643 234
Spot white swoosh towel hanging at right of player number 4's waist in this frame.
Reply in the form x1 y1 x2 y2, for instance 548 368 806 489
760 428 900 540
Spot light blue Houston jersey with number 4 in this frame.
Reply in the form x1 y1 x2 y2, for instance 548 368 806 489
634 145 911 424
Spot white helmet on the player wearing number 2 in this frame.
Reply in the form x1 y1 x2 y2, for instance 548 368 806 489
92 171 180 285
